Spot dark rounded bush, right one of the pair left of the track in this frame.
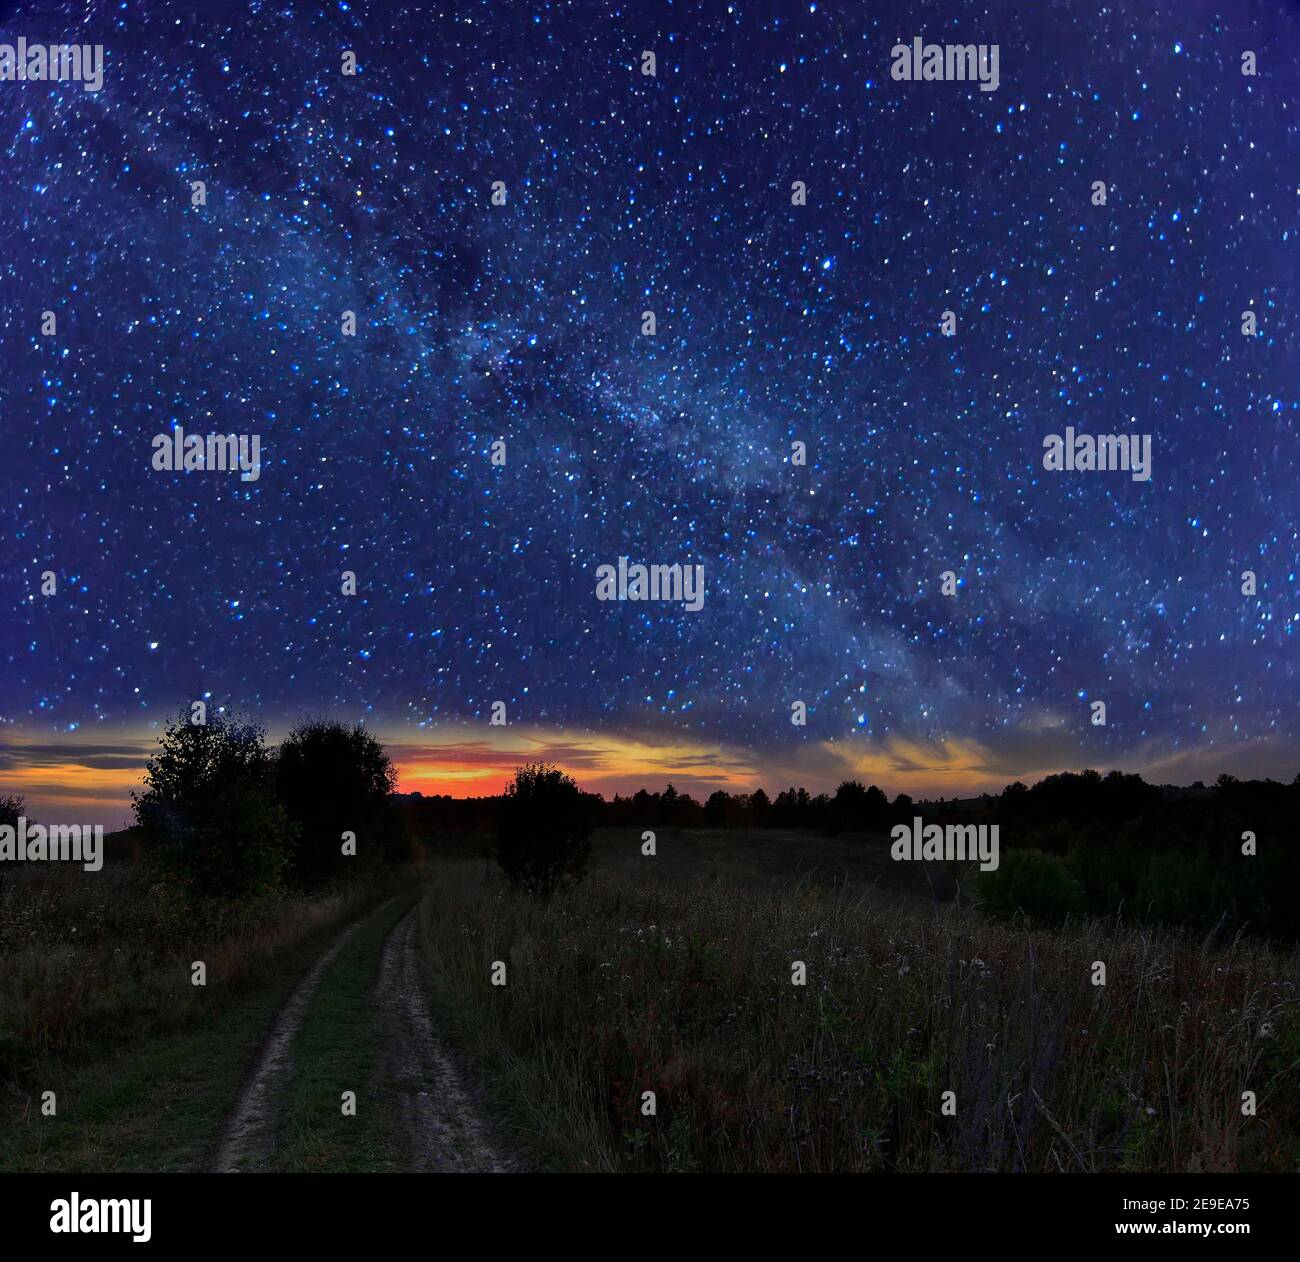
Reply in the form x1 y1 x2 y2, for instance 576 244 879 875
276 720 408 888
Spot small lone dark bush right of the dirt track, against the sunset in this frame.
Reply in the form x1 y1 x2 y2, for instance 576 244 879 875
497 763 592 898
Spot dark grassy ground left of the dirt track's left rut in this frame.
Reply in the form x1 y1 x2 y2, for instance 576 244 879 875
0 859 400 1171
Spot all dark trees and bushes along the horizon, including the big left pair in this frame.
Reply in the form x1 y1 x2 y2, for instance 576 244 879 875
0 743 1300 940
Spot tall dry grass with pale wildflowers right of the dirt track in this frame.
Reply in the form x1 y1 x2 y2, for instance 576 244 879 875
423 863 1300 1171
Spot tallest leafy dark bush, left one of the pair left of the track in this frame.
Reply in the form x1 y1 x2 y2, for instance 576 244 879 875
131 707 295 899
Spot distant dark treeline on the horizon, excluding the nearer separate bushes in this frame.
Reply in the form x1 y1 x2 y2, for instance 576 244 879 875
403 771 1300 941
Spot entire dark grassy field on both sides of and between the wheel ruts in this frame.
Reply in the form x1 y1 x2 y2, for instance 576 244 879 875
0 829 1300 1171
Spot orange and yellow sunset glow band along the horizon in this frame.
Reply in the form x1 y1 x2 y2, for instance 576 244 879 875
0 721 1294 828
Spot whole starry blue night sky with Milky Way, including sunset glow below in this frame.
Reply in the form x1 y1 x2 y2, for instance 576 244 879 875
0 0 1300 826
